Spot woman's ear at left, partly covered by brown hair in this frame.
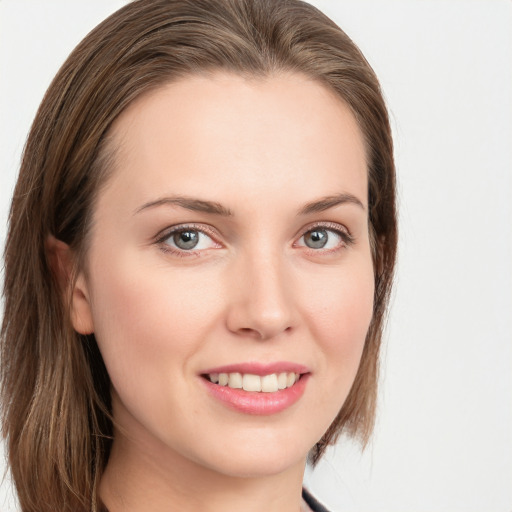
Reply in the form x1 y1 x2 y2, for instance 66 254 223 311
46 235 94 334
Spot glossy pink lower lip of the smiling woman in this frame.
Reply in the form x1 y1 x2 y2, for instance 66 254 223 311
201 374 309 416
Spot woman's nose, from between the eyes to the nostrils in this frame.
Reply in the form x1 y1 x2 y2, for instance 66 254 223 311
226 248 297 340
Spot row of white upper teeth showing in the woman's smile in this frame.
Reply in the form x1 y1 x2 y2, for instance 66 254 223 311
208 372 300 393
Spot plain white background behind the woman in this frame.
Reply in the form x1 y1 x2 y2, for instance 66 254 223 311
0 0 512 512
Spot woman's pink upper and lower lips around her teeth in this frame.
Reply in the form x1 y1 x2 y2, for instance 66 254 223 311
201 362 310 415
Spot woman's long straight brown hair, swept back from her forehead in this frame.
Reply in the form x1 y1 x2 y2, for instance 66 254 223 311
1 0 397 512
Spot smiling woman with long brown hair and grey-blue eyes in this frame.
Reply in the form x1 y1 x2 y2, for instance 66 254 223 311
2 0 396 512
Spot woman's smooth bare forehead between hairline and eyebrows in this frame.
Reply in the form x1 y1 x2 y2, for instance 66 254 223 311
101 72 367 210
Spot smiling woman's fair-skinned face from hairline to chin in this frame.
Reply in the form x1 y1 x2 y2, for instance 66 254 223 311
74 73 374 476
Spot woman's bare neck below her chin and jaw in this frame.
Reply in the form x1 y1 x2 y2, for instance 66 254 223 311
100 432 305 512
